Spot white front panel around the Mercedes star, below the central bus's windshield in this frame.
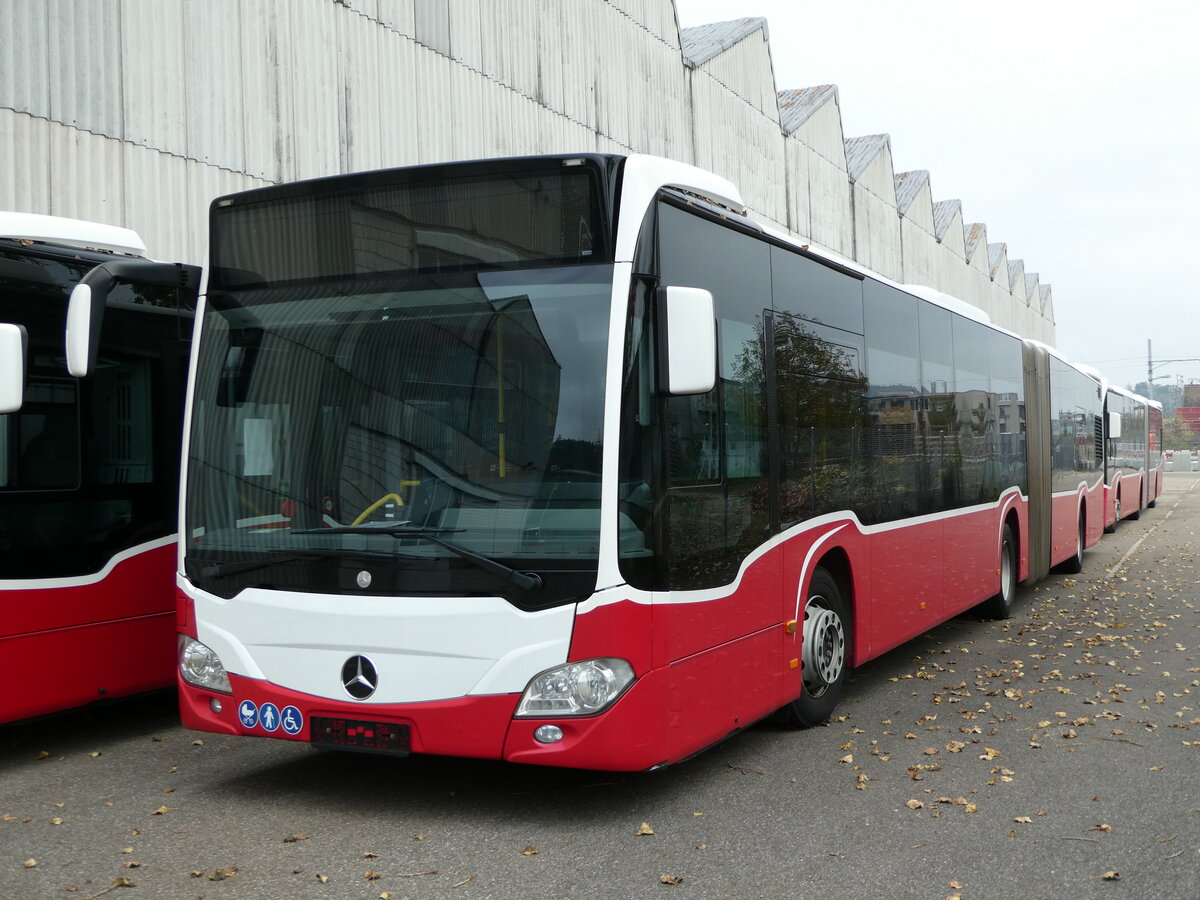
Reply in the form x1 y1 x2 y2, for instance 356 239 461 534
188 580 575 703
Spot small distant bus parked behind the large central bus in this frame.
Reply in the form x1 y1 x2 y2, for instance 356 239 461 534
1104 384 1165 533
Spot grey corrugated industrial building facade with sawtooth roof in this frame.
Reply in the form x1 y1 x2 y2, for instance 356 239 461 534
0 0 1055 344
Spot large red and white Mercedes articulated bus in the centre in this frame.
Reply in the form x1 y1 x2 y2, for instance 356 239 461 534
75 155 1132 769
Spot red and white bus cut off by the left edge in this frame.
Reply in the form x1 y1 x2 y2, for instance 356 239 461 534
0 212 197 722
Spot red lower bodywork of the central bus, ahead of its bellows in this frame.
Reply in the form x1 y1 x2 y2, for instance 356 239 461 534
178 491 1028 770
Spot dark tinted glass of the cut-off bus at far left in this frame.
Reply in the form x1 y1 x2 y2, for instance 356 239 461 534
0 251 191 578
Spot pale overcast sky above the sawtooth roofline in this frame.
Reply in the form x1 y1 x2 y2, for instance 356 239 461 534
676 0 1200 385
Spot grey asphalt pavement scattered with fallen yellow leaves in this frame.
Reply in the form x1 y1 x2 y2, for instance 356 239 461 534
0 472 1200 900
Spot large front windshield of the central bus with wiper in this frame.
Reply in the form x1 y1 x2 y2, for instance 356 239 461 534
186 264 619 607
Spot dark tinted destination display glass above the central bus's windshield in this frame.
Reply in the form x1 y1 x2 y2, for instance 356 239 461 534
210 163 610 289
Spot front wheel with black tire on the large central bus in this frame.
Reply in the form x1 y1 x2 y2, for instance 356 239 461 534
780 569 850 728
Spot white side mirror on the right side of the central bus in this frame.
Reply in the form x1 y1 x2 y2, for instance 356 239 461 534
659 287 716 396
